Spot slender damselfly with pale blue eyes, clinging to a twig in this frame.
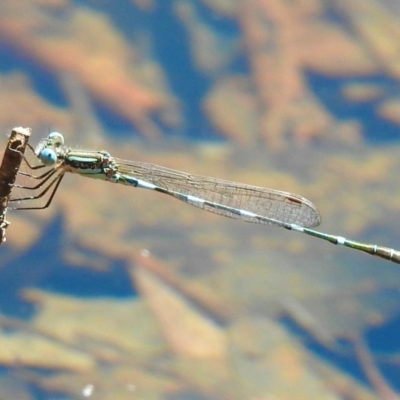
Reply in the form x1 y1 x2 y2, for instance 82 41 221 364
11 132 400 264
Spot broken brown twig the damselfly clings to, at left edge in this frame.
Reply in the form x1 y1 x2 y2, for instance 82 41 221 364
0 128 31 244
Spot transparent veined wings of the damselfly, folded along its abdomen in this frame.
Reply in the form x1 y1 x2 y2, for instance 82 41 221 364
113 158 321 227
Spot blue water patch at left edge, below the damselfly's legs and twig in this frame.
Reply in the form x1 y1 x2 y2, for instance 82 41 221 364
0 214 135 318
